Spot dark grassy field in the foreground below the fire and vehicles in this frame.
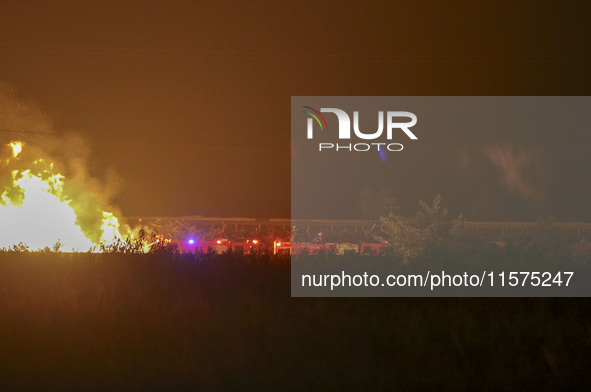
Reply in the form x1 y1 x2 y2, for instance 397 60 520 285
0 253 591 391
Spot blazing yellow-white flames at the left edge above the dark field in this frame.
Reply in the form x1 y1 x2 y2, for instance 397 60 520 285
0 142 129 251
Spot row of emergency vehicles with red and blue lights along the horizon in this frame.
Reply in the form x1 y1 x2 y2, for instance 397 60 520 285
165 238 388 256
